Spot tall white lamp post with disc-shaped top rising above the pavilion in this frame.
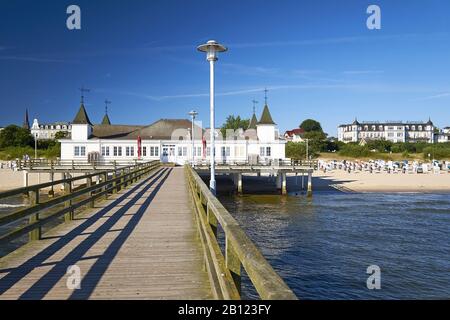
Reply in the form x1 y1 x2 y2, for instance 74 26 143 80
197 40 227 194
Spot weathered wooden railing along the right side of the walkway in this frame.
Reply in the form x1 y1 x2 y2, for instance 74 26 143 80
185 165 297 300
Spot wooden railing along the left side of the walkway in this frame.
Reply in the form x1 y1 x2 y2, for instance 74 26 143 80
0 161 160 245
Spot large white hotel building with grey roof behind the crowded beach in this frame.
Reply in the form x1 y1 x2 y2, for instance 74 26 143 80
338 120 435 143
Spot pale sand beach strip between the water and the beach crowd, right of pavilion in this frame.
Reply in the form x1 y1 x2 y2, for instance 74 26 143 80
313 170 450 193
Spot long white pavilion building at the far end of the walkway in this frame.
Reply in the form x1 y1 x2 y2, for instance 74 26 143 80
60 105 286 165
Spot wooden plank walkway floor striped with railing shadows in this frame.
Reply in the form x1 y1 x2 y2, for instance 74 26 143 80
0 168 212 300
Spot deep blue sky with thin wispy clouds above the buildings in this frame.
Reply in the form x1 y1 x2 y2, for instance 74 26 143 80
0 0 450 136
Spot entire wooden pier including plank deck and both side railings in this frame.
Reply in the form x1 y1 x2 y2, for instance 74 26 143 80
0 162 296 299
